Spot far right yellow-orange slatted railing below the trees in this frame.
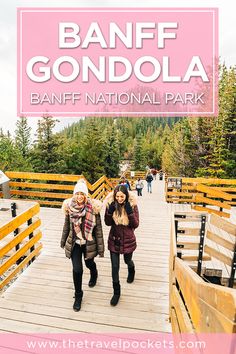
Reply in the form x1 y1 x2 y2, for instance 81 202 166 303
165 177 236 217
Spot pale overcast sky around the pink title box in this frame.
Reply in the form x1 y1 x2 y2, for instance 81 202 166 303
0 0 236 133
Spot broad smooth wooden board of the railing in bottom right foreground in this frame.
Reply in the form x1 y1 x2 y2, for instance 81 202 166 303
174 257 236 333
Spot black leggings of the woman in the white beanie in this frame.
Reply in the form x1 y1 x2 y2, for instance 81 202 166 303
71 243 97 293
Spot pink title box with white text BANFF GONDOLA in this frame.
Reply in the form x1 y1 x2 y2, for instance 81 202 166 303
18 8 218 117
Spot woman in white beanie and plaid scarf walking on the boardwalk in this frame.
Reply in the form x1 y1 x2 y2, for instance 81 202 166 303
61 180 104 311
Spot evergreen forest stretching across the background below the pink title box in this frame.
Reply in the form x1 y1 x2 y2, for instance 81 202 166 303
0 65 236 183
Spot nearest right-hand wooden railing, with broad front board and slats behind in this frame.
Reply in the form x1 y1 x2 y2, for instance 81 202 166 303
169 212 236 333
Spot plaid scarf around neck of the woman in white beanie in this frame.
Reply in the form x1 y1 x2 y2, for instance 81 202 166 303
68 197 96 241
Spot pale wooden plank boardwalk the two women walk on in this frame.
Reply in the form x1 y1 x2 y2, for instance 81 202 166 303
0 181 172 333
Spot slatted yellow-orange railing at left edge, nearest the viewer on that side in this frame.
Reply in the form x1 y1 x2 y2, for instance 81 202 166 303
0 200 42 290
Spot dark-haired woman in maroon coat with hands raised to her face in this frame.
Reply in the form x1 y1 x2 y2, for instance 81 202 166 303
105 185 139 306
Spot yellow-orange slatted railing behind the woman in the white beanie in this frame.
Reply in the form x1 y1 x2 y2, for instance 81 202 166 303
0 171 113 206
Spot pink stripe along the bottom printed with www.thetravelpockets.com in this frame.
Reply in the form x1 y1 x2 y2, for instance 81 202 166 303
0 334 236 354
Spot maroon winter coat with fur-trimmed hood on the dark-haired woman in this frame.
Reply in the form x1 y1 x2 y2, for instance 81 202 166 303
105 192 139 254
